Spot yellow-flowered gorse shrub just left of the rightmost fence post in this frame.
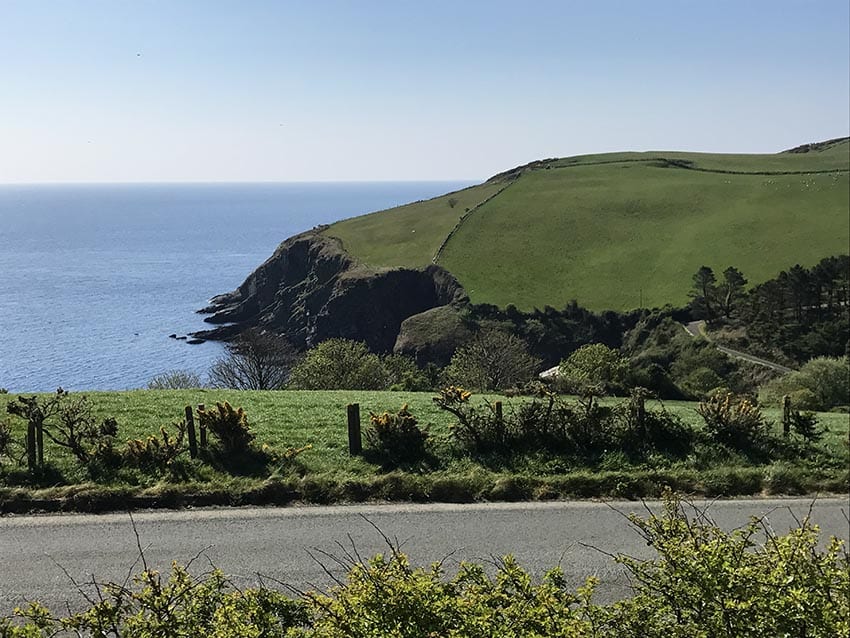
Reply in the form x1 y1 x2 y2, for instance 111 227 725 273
697 393 770 452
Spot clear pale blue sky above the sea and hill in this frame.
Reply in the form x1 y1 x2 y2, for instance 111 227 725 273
0 0 850 183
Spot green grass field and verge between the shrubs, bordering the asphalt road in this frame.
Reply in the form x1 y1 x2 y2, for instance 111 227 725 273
0 390 848 511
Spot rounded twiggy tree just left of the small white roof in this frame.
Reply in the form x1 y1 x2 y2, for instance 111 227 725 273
446 329 540 391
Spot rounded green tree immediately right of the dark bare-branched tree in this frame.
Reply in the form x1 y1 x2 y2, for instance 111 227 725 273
289 339 391 390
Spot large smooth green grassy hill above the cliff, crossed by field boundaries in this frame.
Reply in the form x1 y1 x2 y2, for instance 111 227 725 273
326 138 850 310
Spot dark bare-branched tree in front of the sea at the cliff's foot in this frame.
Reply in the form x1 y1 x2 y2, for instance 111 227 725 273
209 328 300 390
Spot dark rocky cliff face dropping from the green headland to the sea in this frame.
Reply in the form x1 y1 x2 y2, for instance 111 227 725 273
195 231 467 352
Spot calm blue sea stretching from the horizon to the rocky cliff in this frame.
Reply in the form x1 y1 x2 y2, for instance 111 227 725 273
0 182 468 392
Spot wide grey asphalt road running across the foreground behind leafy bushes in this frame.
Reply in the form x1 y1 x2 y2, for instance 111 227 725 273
0 499 850 615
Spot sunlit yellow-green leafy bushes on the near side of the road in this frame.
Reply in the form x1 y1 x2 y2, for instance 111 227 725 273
0 499 850 638
